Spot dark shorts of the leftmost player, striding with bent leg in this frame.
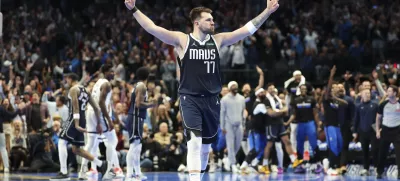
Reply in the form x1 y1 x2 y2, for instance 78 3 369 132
60 121 85 147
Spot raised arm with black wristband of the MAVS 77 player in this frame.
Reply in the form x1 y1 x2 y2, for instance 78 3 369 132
125 0 187 47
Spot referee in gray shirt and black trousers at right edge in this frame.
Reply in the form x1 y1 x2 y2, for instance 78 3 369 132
376 85 400 179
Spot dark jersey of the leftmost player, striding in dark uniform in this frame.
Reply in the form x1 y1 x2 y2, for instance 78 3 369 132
63 85 89 128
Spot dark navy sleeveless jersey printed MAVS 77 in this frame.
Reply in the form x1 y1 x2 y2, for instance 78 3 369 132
178 34 222 96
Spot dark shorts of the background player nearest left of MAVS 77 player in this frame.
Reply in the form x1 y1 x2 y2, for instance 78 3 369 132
126 114 144 143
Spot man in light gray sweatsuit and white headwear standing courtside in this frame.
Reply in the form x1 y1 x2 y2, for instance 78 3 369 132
221 81 246 173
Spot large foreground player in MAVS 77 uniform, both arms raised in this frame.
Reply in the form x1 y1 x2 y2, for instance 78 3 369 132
125 0 279 181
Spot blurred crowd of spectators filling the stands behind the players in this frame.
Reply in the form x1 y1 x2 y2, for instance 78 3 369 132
0 0 400 174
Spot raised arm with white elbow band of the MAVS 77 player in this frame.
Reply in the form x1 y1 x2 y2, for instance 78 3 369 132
215 0 279 47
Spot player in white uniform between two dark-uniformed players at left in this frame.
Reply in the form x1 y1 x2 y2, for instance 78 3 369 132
78 64 124 179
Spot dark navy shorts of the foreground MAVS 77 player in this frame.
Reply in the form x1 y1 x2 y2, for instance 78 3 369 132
179 95 221 144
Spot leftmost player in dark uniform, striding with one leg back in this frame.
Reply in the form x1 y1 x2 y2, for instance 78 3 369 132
50 73 107 180
